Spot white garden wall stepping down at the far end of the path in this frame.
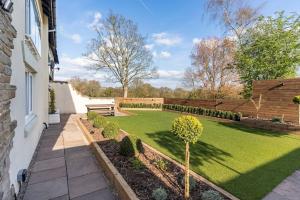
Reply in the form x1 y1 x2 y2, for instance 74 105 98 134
50 82 115 114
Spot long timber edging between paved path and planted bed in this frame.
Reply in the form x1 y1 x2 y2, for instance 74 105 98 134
76 118 138 200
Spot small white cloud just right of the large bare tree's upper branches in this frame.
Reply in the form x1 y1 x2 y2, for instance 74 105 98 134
152 32 182 46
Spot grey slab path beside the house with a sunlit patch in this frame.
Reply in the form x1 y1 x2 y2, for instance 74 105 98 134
23 115 116 200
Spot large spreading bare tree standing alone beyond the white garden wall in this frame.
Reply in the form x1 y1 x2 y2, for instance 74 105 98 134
86 13 156 98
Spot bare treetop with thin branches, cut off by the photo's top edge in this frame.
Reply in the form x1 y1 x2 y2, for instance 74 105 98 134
206 0 263 42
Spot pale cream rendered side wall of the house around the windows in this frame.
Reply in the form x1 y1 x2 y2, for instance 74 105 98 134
10 0 49 192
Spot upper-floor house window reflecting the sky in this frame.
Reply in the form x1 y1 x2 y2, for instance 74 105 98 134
26 0 41 55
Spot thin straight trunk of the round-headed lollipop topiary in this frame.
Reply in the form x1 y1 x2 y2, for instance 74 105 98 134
184 142 190 200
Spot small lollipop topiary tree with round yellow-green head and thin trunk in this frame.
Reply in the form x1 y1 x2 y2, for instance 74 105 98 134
171 116 203 199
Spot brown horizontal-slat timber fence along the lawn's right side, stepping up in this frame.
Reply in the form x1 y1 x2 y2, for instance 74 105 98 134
164 78 300 123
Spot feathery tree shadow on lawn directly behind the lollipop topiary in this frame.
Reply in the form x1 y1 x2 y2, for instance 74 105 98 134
146 131 235 168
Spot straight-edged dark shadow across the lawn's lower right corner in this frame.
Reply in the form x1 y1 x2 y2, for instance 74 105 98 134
220 147 300 200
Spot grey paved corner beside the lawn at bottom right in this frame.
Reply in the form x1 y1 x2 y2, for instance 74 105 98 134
263 170 300 200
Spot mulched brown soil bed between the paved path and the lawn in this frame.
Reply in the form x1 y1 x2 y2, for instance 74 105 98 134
81 115 229 200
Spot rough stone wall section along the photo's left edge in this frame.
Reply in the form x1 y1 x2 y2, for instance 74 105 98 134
0 8 17 200
